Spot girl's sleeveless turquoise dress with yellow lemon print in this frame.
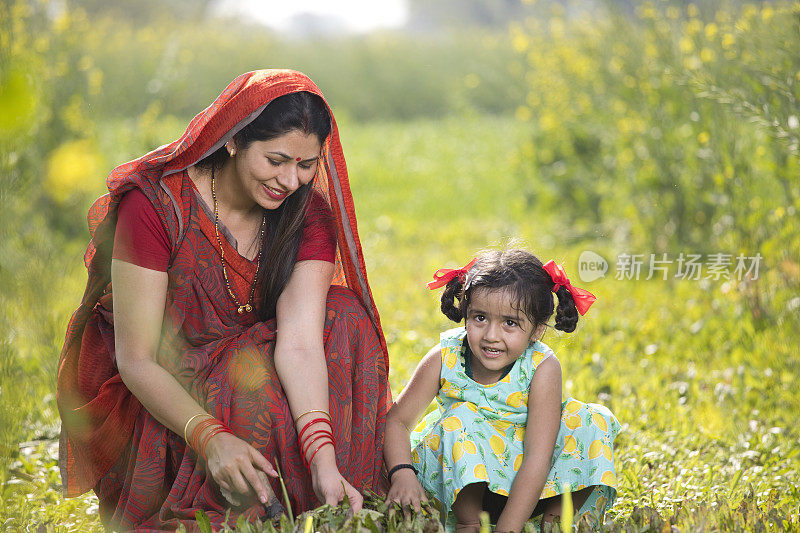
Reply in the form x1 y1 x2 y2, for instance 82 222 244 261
411 327 620 529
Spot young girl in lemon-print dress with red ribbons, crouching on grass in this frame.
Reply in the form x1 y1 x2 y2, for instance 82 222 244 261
384 250 620 531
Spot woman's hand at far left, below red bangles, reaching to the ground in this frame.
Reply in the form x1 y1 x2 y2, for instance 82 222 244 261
206 433 278 505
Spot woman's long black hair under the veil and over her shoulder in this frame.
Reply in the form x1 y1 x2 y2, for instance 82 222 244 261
197 92 331 320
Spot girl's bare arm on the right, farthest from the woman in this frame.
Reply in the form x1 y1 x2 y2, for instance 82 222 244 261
496 355 561 531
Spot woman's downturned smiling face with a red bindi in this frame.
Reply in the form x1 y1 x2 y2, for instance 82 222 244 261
233 130 322 209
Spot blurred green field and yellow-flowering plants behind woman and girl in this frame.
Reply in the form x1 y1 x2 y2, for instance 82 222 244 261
0 0 800 529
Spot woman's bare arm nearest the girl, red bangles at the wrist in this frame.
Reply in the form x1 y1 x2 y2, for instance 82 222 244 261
275 260 364 511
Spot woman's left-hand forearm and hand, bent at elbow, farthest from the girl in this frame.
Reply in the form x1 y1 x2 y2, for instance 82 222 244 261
111 259 277 503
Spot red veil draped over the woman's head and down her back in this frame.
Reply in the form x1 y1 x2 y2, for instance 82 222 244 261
56 70 388 496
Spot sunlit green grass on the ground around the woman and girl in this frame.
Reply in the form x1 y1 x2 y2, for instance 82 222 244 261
0 116 800 531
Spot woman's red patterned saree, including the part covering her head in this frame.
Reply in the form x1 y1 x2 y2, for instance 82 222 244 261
57 70 391 531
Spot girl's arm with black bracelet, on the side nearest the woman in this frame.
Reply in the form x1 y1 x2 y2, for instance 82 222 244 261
383 346 442 510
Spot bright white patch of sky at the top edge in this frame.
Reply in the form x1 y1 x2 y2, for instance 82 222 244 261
218 0 407 32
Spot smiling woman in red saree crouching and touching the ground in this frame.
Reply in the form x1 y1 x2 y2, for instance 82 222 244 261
58 71 391 530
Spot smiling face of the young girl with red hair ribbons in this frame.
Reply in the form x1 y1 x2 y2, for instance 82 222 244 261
466 289 537 385
